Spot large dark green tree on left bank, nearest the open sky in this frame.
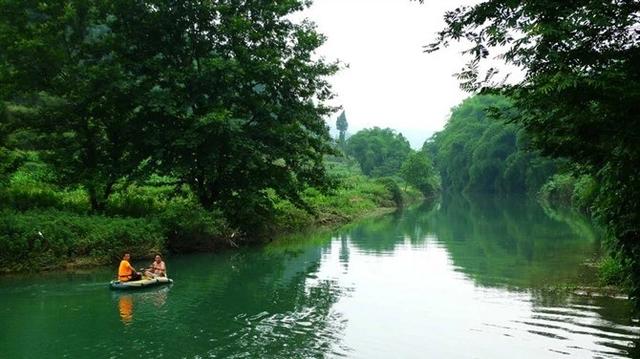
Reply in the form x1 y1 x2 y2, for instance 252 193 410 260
148 0 337 231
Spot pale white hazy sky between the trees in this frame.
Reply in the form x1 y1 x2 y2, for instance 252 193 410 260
303 0 478 148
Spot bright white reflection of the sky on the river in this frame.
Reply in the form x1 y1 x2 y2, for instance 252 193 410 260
318 237 640 358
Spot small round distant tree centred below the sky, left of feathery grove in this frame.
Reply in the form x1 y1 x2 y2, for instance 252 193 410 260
346 127 411 177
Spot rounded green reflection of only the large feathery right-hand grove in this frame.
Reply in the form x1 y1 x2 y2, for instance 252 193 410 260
426 196 599 288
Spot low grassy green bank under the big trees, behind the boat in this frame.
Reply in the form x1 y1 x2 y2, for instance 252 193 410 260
0 163 421 272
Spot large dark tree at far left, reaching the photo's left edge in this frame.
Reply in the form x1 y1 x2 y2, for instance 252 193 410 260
0 0 165 210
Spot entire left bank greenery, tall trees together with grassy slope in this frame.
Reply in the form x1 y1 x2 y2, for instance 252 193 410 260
0 0 424 270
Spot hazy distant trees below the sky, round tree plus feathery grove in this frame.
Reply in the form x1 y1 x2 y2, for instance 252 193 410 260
337 95 566 195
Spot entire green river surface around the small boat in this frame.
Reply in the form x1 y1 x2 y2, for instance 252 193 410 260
0 198 640 359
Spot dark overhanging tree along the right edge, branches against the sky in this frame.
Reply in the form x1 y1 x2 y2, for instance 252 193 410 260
429 0 640 299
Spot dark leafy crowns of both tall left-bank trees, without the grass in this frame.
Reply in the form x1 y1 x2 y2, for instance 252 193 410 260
0 0 337 229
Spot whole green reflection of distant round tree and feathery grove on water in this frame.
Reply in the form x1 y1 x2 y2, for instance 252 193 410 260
343 196 599 288
